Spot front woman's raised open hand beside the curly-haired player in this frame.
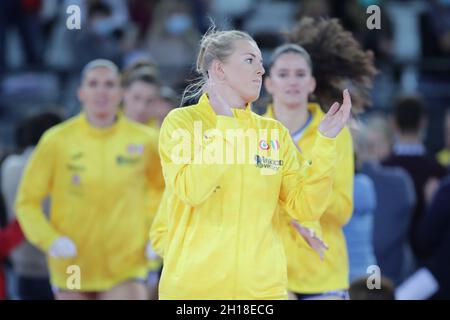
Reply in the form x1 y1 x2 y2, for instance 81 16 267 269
319 89 352 138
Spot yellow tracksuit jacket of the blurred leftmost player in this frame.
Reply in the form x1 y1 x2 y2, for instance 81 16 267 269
16 113 164 291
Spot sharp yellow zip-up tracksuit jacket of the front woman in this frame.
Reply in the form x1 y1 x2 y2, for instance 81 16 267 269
151 94 336 299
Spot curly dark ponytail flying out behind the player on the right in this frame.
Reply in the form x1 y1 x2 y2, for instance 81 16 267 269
285 17 377 112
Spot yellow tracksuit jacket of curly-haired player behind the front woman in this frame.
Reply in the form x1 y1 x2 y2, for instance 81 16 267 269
265 103 354 294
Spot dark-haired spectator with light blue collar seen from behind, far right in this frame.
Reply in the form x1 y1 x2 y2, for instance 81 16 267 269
383 95 445 260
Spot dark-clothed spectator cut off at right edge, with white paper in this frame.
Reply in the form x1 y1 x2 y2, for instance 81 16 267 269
397 176 450 299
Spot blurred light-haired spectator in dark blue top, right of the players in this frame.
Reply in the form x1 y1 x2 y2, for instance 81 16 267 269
353 116 415 284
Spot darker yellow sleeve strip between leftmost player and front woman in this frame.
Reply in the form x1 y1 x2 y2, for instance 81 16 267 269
147 130 164 219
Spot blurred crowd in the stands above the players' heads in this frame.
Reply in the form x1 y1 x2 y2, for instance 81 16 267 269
0 0 450 152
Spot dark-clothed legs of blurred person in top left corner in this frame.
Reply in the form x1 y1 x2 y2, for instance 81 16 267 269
0 0 43 73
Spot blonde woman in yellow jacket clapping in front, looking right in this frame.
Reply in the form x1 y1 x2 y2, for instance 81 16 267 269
150 30 351 299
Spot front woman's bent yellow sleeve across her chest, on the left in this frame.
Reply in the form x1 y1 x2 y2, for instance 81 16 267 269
159 110 235 207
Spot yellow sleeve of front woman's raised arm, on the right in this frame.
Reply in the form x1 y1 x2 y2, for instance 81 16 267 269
280 129 336 237
